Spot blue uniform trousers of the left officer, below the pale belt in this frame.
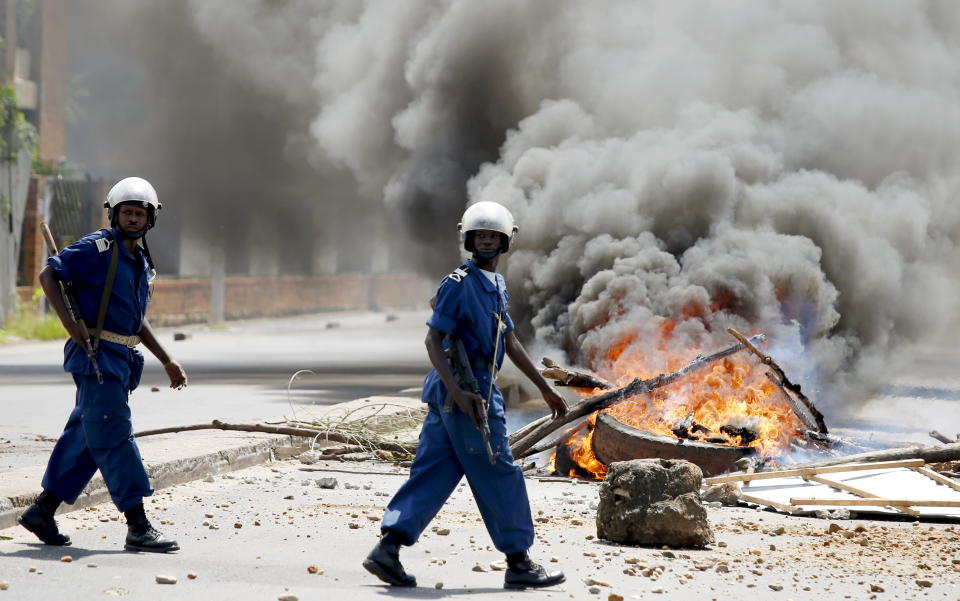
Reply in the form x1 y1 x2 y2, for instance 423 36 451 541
43 374 153 511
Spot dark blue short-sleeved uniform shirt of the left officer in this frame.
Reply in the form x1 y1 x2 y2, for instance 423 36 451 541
47 230 150 390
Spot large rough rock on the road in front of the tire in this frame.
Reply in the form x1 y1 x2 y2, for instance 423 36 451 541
597 459 713 547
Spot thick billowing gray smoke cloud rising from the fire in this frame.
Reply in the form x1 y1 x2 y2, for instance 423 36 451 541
131 0 960 412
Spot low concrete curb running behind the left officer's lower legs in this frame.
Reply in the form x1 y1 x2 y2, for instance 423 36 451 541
0 435 294 530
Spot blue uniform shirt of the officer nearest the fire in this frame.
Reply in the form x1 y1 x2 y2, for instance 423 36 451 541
423 261 513 403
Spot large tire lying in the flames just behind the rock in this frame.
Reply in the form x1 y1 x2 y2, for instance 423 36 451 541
593 412 755 476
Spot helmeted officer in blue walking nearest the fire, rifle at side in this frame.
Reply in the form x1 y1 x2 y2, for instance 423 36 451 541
363 202 566 589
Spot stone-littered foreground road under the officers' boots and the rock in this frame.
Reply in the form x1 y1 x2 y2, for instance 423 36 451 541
0 454 958 601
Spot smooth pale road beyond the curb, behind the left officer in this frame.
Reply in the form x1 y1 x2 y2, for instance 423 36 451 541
0 311 429 472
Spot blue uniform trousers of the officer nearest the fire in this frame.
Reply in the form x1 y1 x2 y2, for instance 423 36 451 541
381 382 533 553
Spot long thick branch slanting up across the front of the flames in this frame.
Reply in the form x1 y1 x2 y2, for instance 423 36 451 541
510 334 765 459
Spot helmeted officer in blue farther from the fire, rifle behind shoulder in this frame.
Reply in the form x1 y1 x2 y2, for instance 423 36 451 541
18 177 187 553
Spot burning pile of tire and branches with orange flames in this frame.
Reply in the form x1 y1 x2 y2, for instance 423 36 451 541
511 328 834 478
